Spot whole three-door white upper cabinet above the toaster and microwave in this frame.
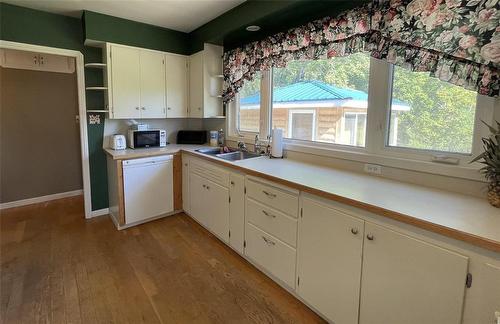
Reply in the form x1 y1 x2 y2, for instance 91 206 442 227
104 44 188 119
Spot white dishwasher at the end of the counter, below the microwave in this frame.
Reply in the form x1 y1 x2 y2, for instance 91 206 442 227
122 155 174 224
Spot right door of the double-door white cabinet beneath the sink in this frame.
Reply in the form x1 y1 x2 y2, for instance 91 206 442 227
205 180 229 242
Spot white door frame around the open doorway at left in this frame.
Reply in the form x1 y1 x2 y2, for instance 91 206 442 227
0 40 92 218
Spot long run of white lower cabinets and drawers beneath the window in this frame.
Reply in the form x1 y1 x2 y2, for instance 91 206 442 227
183 157 484 324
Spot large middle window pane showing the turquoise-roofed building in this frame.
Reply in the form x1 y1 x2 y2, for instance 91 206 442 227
272 53 370 146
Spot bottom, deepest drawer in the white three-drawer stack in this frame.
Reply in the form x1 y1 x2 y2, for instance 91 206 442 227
245 223 296 289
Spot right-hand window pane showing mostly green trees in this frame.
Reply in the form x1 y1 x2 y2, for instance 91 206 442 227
388 67 477 154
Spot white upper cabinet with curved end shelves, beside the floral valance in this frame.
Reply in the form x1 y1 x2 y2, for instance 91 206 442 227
189 44 223 118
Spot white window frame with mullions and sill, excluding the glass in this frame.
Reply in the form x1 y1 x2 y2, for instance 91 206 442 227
227 58 500 180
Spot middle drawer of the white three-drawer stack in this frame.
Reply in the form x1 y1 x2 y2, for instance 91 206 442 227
246 198 297 247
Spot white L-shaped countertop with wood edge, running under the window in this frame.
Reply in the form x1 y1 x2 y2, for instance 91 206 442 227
102 144 500 252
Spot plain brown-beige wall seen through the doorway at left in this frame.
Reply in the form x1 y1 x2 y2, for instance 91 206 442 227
0 68 82 203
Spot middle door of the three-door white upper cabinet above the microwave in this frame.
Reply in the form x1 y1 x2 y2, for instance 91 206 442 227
140 51 166 118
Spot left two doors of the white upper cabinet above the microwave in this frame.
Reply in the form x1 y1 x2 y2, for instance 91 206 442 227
108 45 166 119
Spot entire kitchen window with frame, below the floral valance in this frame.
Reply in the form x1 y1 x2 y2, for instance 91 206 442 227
228 53 498 179
